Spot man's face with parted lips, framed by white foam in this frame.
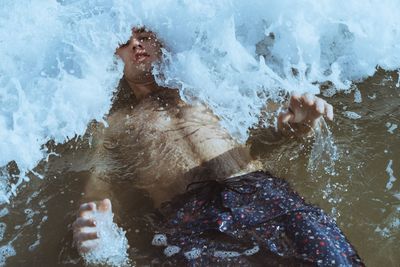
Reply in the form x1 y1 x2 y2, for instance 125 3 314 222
116 28 162 82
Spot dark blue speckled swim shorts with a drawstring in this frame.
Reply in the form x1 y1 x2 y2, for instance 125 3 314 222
153 171 364 266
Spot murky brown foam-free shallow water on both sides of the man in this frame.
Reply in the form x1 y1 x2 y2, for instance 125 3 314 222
0 71 400 266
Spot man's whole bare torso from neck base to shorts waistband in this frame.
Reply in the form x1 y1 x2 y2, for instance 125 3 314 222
98 90 250 205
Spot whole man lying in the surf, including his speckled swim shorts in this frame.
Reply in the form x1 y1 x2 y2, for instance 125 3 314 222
73 28 362 265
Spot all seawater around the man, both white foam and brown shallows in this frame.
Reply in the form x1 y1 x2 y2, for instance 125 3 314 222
0 0 400 266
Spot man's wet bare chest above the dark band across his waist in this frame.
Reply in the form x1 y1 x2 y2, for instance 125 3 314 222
104 99 237 168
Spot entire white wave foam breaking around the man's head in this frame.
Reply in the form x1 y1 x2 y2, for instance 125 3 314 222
0 0 400 205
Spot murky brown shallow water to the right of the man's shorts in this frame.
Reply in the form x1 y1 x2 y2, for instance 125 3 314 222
252 71 400 266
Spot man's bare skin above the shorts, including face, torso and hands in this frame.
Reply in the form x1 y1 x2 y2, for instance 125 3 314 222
73 28 362 266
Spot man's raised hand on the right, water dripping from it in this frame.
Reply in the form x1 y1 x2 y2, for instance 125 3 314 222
278 93 333 135
